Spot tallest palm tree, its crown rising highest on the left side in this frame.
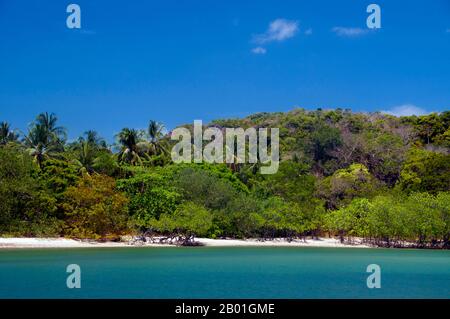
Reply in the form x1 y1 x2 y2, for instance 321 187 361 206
24 113 66 168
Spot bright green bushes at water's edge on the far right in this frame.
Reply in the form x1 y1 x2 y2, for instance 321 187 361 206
326 193 450 246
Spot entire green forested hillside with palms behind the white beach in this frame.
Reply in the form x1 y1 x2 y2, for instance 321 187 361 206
0 109 450 248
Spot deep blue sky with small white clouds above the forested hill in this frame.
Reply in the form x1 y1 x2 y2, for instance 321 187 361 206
0 0 450 141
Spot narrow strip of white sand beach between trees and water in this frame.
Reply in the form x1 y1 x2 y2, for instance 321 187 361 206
0 237 376 250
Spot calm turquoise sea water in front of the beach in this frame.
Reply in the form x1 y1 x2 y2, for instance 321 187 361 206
0 247 450 298
